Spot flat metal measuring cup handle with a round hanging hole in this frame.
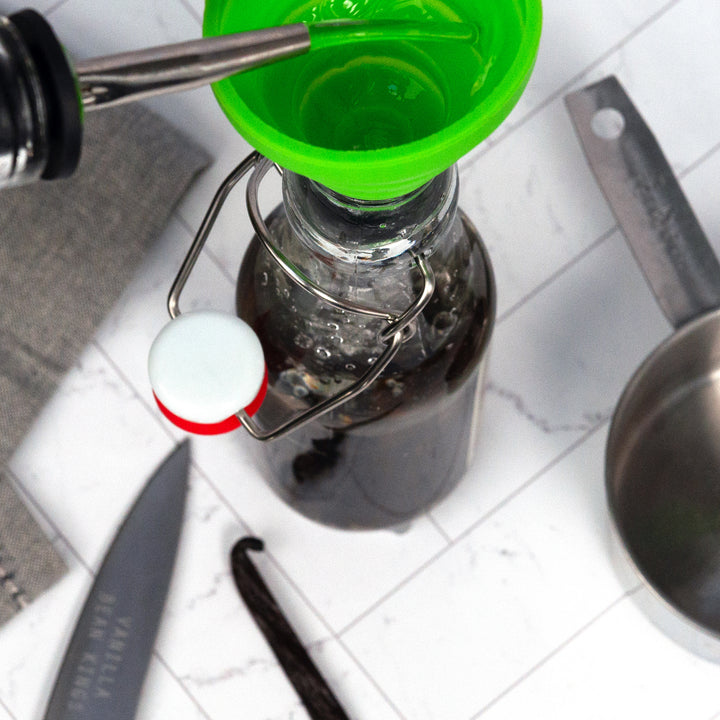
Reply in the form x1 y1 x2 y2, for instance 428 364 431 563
565 76 720 328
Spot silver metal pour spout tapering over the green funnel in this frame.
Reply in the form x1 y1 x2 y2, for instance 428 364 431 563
74 23 310 111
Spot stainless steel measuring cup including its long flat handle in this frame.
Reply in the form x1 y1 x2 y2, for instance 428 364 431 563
565 77 720 661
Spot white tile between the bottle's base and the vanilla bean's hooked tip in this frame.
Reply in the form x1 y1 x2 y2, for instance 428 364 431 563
195 436 447 632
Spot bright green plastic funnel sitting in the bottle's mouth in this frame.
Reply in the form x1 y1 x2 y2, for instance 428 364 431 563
203 0 542 200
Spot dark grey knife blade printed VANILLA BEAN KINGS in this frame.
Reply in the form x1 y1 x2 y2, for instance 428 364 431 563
45 440 190 720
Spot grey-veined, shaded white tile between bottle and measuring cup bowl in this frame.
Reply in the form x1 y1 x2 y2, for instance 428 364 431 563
433 228 670 537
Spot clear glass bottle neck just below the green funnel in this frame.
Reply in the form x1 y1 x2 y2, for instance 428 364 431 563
283 166 458 266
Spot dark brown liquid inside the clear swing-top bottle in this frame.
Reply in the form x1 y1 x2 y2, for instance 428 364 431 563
237 211 494 528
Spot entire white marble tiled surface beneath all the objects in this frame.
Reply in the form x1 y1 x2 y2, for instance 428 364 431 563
0 0 720 720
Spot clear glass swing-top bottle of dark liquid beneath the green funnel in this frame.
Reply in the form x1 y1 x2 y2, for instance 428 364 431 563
237 167 495 529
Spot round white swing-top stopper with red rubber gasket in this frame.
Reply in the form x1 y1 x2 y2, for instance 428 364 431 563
148 310 266 432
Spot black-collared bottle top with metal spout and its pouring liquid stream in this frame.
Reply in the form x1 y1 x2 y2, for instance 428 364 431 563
0 10 484 188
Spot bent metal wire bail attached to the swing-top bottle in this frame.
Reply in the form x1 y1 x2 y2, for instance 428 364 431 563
167 151 435 441
